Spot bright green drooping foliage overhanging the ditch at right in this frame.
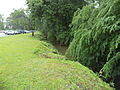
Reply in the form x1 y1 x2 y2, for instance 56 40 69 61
66 0 120 83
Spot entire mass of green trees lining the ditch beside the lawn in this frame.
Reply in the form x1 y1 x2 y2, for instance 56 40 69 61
27 0 120 88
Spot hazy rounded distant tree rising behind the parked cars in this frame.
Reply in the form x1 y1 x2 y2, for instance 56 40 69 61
6 9 32 30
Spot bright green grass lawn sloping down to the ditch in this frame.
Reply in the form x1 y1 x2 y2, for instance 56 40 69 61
0 34 111 90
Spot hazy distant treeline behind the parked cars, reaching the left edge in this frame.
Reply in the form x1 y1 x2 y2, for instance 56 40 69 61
0 8 33 30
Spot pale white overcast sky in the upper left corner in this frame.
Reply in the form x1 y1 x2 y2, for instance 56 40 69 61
0 0 27 18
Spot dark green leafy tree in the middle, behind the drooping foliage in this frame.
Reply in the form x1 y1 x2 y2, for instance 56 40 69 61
27 0 86 44
